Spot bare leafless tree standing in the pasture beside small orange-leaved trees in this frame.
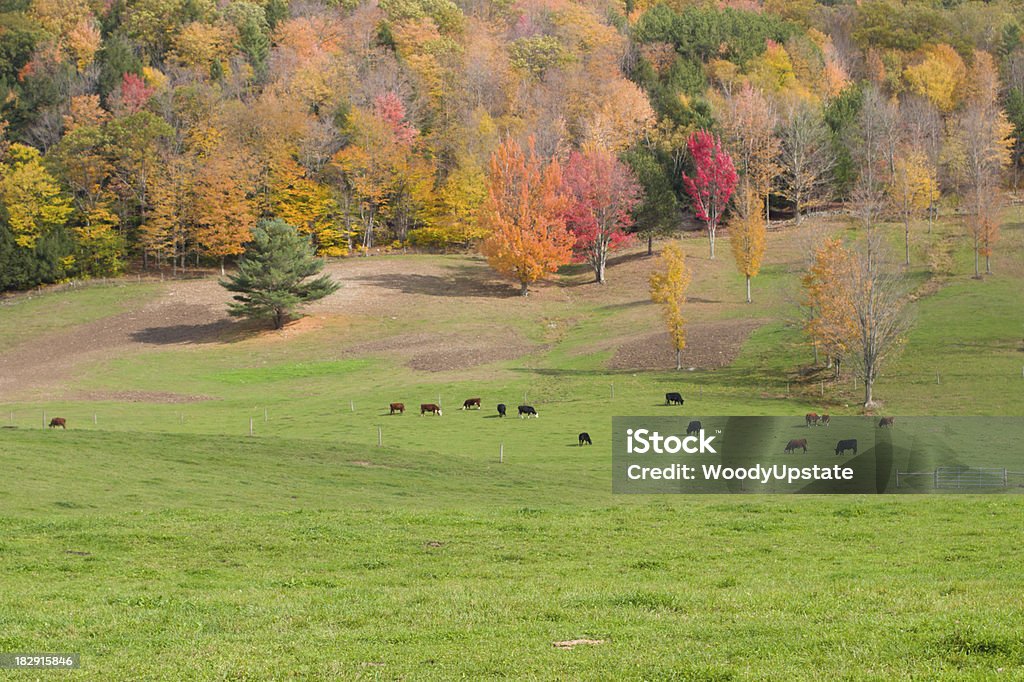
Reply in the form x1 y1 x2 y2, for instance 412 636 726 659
847 229 910 409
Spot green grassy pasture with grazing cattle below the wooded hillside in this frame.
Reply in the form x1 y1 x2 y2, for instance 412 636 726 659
0 213 1024 680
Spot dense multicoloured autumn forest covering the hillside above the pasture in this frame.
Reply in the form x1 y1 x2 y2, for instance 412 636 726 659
0 0 1024 293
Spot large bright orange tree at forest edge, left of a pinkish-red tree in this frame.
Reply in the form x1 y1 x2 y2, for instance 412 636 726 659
480 137 574 296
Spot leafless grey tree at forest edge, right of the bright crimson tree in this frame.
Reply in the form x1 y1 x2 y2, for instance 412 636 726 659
779 105 836 225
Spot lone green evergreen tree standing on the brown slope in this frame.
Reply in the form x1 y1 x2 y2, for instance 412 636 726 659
220 219 339 329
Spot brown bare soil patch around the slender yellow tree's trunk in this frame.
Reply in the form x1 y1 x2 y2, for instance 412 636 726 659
608 319 768 370
